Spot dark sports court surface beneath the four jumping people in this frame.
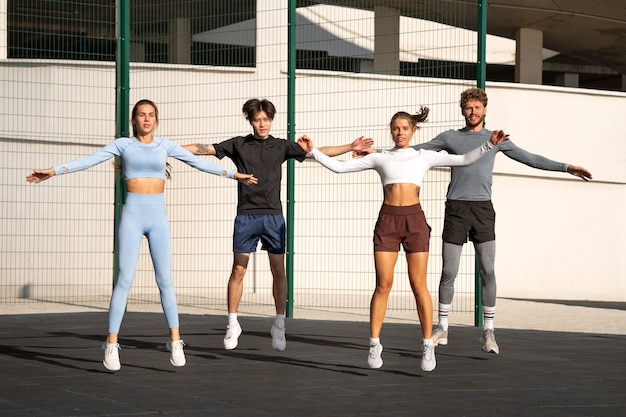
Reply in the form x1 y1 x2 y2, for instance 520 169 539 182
0 305 626 417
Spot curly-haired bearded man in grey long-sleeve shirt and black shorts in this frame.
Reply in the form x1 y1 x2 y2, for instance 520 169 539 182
413 88 591 354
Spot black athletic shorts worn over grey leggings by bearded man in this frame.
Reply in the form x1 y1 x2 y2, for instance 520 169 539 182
442 200 496 245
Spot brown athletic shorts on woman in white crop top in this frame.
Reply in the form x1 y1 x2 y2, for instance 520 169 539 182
374 204 431 253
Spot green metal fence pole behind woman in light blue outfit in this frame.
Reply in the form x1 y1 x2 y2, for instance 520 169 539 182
113 0 130 287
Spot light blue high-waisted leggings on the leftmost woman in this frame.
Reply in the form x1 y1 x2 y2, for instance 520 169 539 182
109 193 179 333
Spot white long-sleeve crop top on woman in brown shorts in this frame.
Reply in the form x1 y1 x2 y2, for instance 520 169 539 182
311 141 494 187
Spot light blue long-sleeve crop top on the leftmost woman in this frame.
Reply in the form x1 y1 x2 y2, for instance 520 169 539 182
54 137 235 180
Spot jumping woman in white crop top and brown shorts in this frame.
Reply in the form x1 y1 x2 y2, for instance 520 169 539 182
298 107 508 372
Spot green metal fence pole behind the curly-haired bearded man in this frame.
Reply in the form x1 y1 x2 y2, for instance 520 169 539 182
474 0 487 327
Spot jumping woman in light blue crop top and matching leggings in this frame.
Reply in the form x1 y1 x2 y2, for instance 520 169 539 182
26 100 257 371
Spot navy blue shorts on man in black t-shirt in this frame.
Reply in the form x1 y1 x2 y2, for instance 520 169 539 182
233 214 285 255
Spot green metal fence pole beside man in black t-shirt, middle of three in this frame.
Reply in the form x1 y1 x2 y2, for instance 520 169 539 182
285 0 296 318
